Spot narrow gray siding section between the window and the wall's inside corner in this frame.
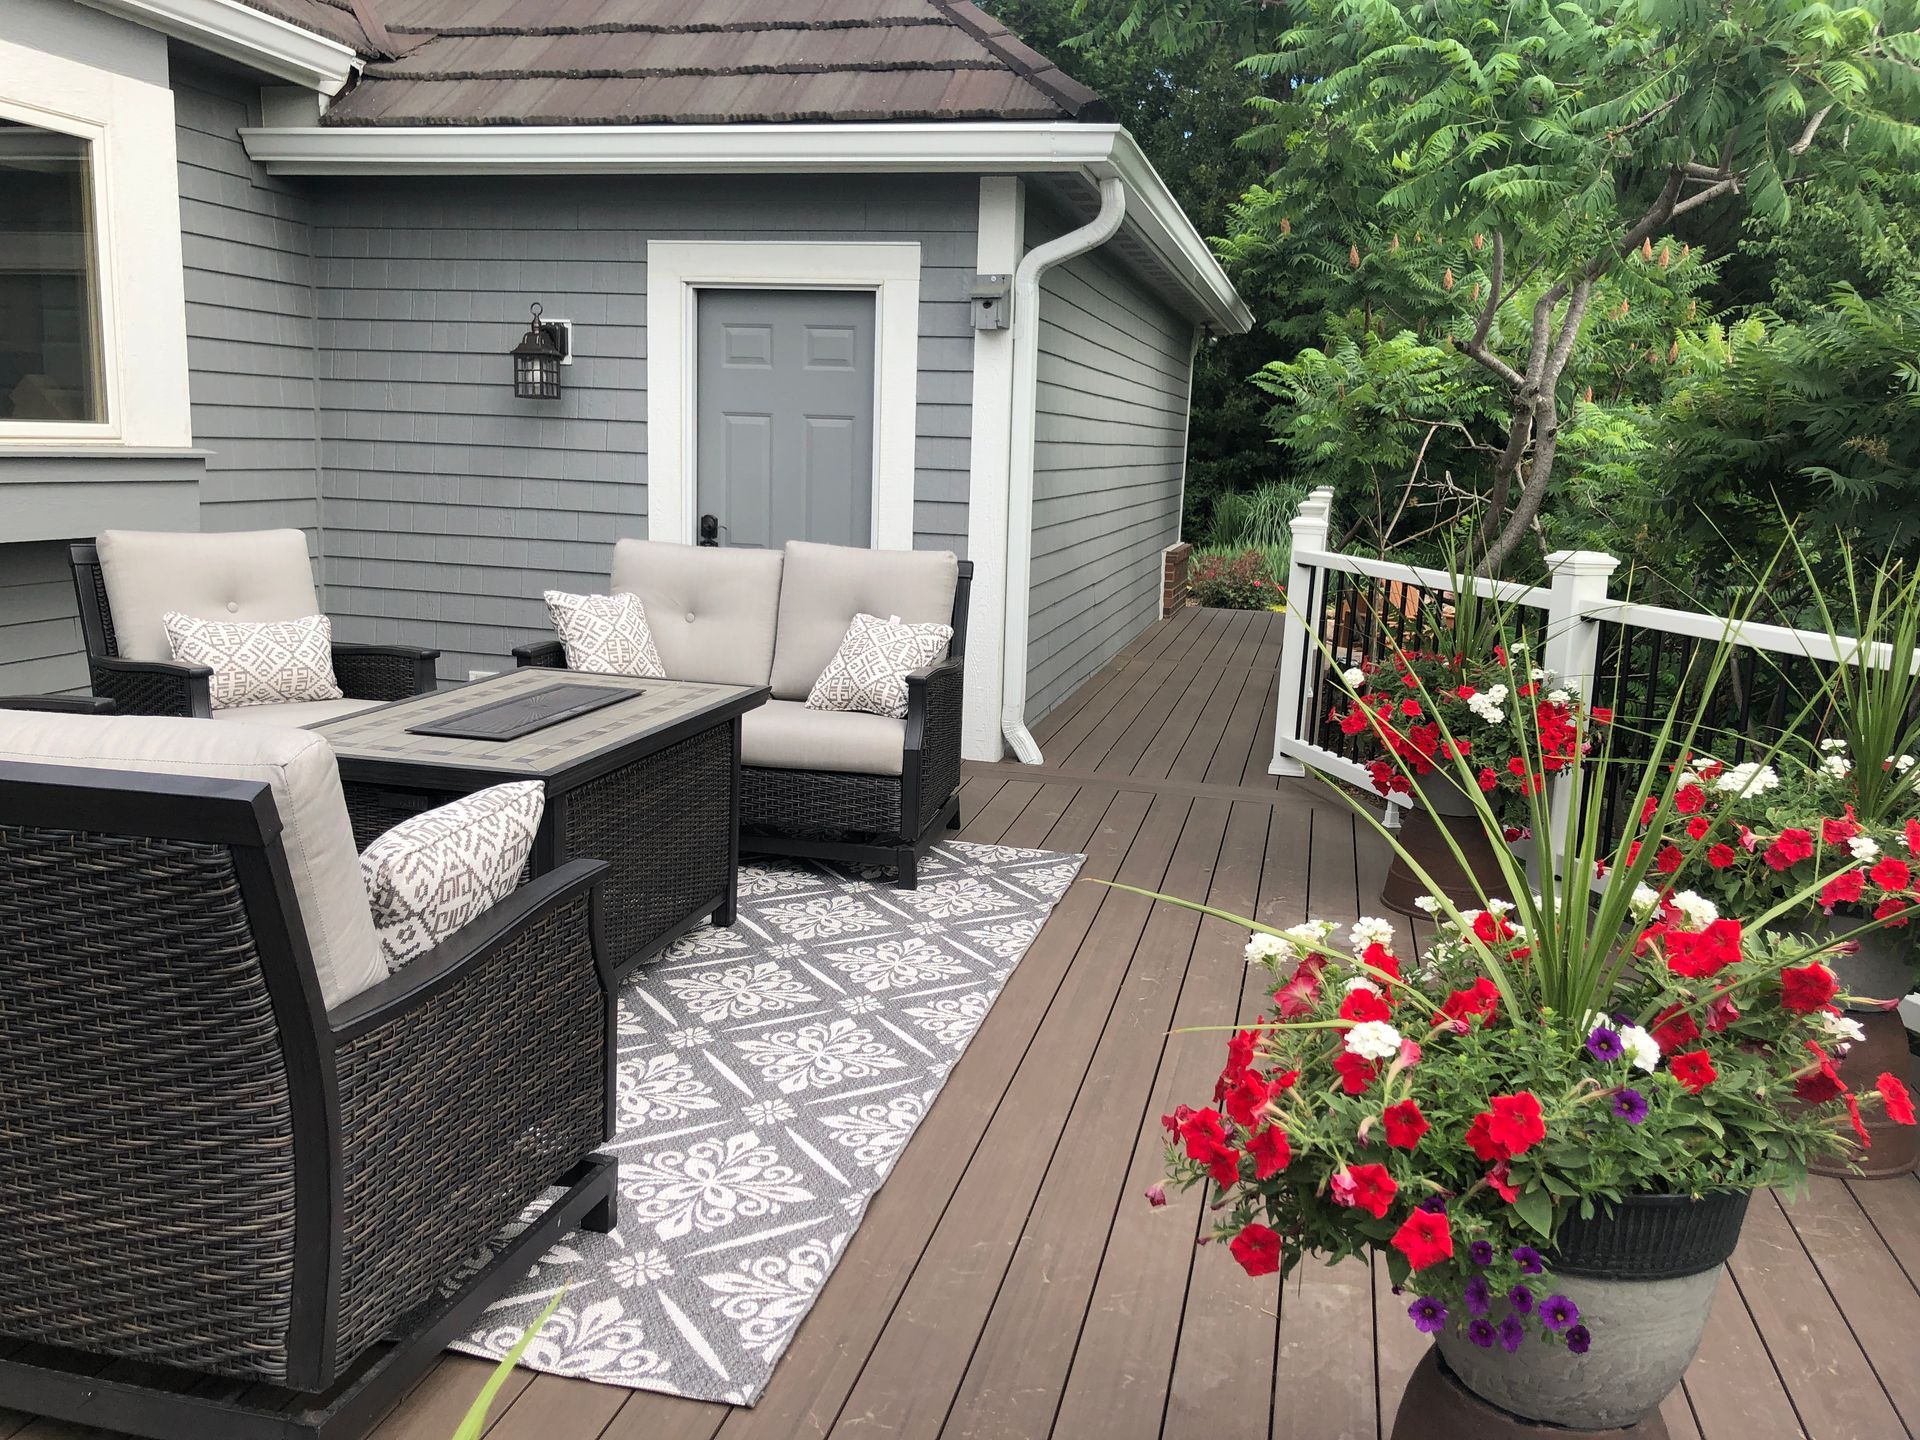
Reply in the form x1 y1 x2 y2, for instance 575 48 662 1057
173 63 321 553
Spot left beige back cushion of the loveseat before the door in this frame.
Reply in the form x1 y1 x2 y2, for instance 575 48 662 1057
612 540 781 685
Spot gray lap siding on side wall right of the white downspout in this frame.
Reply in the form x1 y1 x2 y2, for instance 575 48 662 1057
1027 236 1192 724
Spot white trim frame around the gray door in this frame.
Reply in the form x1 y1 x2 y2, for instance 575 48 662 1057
647 240 920 549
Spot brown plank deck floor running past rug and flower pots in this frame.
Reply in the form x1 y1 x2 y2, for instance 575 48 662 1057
0 611 1920 1440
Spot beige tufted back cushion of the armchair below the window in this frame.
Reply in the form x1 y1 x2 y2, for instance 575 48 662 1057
94 530 321 660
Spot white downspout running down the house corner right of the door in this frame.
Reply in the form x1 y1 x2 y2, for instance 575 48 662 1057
1000 179 1127 764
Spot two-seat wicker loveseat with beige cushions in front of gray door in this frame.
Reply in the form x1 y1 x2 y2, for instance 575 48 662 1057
513 540 973 889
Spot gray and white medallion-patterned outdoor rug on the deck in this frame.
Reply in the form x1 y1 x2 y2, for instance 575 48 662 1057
455 841 1083 1405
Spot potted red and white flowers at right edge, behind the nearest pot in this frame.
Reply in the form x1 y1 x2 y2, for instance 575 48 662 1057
1642 737 1920 1175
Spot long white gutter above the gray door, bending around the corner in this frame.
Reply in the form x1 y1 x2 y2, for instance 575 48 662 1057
240 120 1254 334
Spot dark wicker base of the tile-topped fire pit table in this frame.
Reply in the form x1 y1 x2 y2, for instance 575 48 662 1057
346 720 739 977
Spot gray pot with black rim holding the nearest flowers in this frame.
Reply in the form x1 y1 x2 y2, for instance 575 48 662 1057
1438 1192 1747 1432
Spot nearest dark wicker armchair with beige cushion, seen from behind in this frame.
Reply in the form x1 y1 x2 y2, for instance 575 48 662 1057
0 710 614 1440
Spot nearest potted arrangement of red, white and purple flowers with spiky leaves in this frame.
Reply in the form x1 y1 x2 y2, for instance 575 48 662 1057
1148 625 1914 1440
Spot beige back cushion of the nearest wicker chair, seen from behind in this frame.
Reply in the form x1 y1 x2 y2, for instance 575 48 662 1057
0 718 386 1008
